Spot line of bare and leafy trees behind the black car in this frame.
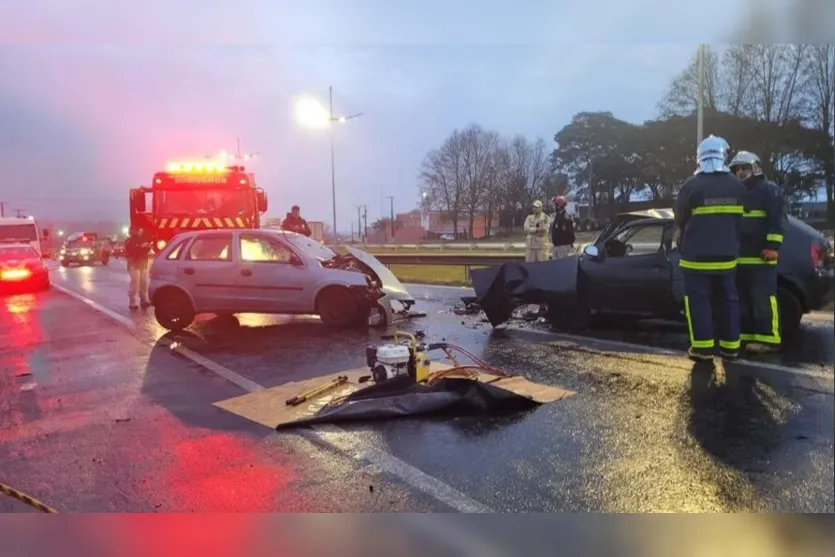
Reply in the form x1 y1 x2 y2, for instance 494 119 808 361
419 45 835 233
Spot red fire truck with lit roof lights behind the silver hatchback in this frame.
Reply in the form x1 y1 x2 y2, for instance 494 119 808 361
130 163 267 251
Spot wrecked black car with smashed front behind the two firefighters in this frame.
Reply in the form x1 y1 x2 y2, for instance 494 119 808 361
472 209 835 337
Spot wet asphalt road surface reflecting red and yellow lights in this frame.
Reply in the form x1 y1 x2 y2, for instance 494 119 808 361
0 261 835 512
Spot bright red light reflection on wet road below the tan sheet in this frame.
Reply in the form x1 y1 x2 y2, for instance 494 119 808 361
168 434 294 513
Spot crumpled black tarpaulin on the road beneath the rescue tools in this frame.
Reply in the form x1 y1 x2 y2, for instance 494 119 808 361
276 376 539 430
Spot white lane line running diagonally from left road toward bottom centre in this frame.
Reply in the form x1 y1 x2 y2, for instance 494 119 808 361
53 284 494 513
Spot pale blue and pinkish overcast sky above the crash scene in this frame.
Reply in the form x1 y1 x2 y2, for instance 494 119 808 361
0 0 824 229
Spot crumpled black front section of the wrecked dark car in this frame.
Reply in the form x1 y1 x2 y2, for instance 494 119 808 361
470 256 579 327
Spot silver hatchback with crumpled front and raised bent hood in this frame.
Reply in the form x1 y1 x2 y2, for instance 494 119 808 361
149 230 415 331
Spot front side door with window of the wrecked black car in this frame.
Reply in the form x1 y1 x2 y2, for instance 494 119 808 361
581 220 673 315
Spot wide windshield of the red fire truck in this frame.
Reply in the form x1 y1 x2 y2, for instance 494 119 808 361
154 188 251 217
